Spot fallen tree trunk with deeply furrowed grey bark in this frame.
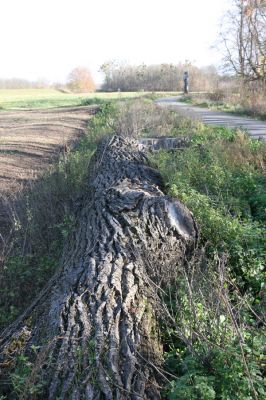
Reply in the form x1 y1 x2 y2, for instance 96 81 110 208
0 136 197 400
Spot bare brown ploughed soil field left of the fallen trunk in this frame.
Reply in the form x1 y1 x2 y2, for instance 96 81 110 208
0 106 96 195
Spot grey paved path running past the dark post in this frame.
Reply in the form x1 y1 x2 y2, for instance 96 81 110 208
156 97 266 140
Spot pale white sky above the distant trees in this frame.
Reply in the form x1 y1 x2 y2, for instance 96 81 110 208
0 0 229 82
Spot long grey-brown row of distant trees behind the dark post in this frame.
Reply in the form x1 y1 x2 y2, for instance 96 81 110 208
101 62 219 91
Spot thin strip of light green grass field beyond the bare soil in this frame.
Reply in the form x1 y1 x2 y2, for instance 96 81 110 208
0 89 148 110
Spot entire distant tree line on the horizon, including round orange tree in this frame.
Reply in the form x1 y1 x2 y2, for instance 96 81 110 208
0 61 220 93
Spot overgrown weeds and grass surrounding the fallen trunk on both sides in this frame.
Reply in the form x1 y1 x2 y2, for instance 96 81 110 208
0 99 266 400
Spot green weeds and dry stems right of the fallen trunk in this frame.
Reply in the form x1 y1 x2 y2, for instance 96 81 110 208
153 128 266 399
